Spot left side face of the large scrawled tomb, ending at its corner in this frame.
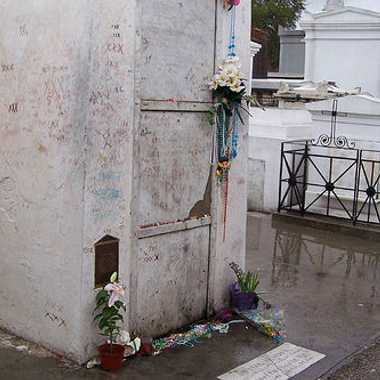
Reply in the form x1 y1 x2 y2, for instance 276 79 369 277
0 0 90 357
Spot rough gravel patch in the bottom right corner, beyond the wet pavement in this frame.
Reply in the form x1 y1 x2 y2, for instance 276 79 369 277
324 341 380 380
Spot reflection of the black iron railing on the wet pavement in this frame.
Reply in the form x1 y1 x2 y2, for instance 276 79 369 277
247 214 380 307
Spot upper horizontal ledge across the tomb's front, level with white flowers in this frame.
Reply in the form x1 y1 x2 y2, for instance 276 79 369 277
140 99 212 112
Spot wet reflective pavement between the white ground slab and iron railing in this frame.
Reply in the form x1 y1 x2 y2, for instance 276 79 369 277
247 214 380 380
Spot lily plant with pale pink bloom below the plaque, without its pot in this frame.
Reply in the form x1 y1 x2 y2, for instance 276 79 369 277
94 273 126 351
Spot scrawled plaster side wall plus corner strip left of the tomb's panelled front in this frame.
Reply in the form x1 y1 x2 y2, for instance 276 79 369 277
0 0 134 360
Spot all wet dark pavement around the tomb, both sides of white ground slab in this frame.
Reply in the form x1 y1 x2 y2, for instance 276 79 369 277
0 214 380 380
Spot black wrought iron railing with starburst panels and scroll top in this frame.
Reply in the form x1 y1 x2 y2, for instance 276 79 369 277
278 141 380 224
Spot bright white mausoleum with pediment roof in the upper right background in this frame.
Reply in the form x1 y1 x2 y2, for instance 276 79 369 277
300 2 380 97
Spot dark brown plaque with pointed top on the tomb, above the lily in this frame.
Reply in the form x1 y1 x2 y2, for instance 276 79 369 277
95 236 119 288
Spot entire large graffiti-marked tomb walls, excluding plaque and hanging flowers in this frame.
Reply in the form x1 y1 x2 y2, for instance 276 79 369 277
0 0 250 361
